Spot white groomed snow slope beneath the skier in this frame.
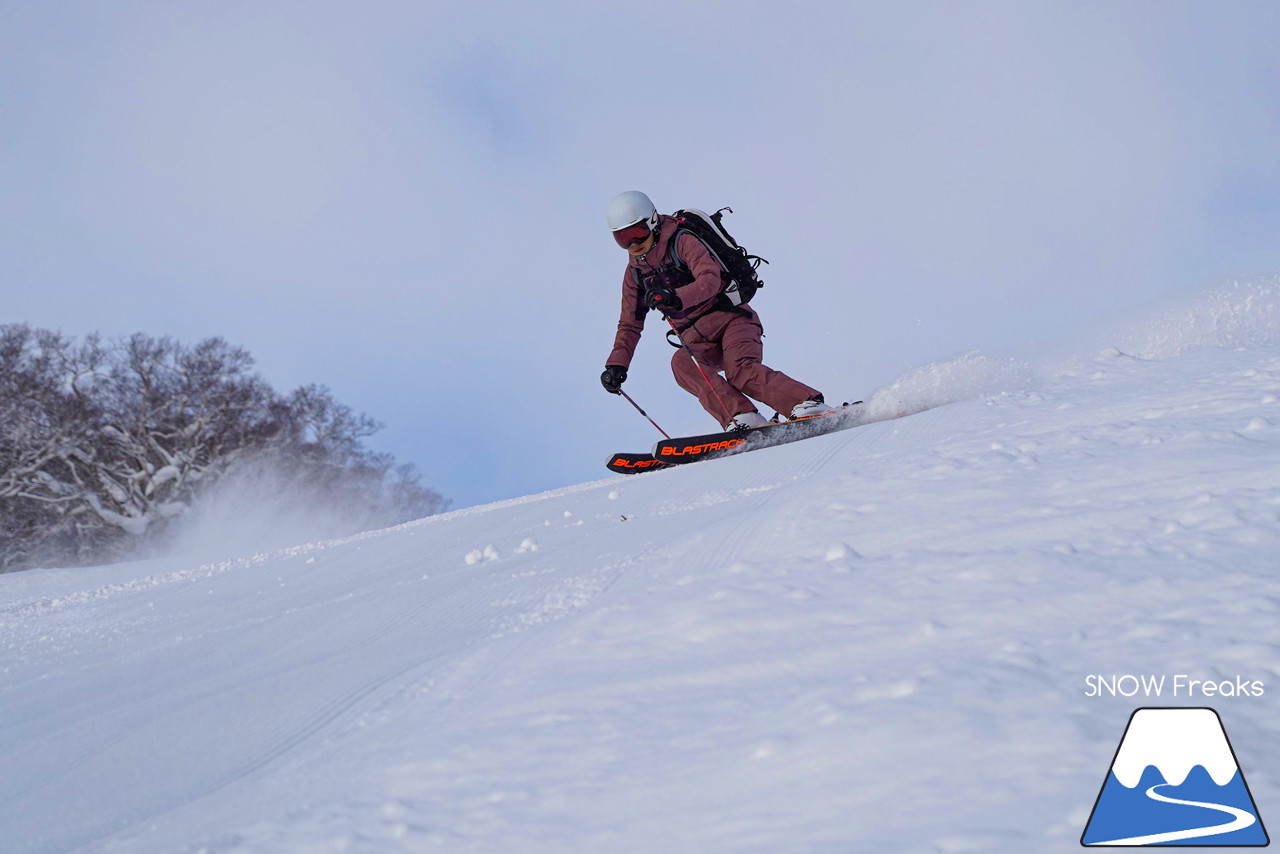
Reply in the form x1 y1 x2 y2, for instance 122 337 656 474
0 283 1280 854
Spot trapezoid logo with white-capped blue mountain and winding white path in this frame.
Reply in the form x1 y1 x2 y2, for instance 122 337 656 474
1080 708 1271 848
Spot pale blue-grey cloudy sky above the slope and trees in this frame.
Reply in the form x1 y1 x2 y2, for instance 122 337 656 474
0 0 1280 506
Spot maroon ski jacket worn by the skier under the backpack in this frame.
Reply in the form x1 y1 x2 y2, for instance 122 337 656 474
604 216 758 367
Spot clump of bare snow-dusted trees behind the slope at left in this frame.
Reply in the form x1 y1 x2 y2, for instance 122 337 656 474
0 325 447 568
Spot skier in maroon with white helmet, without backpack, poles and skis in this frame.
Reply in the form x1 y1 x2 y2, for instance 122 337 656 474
600 189 833 431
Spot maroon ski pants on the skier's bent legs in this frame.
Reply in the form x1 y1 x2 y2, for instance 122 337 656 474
671 312 818 425
